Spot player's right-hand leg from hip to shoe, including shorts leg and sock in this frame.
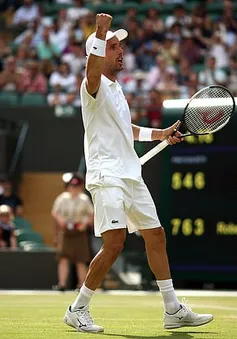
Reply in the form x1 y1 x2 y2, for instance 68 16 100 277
129 183 213 328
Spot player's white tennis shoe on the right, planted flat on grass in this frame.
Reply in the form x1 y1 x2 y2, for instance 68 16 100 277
164 304 213 329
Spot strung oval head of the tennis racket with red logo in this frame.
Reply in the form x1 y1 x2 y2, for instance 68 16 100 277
184 86 234 134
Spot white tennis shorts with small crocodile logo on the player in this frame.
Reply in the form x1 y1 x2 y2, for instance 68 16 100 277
90 177 161 237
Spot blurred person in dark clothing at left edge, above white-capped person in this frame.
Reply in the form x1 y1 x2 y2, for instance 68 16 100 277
0 179 23 217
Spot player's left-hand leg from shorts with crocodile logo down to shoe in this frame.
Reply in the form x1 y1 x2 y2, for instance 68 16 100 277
64 187 126 332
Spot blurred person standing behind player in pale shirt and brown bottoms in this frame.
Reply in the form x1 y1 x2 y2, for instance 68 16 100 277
52 175 93 291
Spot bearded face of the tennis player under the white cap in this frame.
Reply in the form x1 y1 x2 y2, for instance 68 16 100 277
105 36 124 73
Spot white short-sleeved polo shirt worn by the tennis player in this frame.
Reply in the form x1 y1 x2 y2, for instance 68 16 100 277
81 75 141 189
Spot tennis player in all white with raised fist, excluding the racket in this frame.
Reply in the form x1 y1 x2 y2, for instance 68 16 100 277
64 13 213 333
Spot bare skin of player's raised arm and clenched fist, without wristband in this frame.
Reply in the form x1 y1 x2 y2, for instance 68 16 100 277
86 13 112 96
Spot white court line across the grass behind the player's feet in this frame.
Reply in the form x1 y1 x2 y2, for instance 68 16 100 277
0 290 237 297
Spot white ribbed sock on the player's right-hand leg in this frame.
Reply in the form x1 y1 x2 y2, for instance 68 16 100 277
156 279 180 314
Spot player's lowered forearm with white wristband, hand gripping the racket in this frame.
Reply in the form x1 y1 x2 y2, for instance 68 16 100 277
132 121 182 144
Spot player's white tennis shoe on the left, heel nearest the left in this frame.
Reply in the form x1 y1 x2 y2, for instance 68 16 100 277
63 306 104 333
